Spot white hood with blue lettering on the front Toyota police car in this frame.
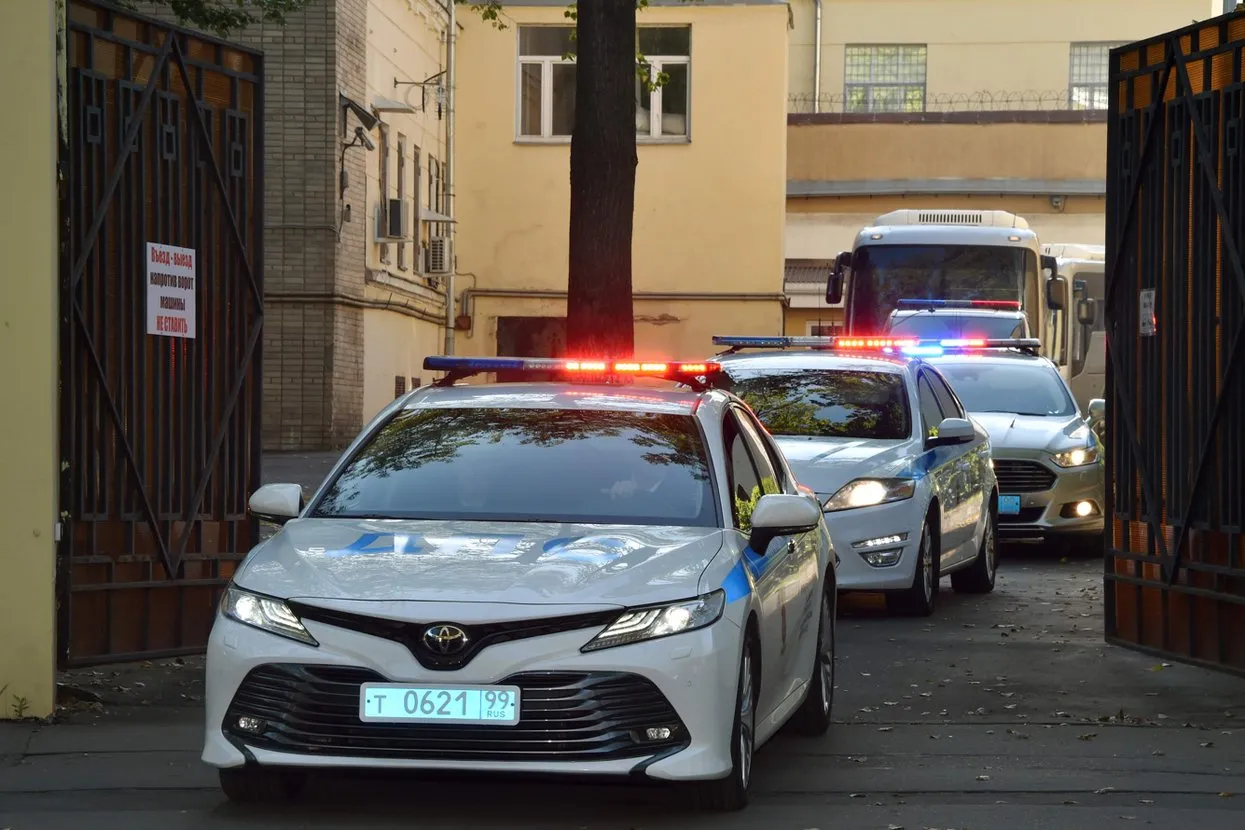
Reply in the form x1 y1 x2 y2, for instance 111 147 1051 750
234 519 725 606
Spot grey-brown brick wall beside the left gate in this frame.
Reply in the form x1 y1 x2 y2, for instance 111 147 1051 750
141 0 367 450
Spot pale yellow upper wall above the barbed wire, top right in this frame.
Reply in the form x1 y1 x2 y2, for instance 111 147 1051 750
789 0 1223 97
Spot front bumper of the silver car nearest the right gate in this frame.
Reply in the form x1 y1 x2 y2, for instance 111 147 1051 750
995 450 1107 540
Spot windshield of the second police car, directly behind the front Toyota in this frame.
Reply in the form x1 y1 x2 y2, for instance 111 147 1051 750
725 366 911 441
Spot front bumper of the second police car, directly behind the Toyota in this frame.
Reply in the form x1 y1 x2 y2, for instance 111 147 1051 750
818 495 925 591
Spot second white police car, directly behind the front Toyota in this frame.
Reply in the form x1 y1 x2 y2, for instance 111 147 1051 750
713 337 997 616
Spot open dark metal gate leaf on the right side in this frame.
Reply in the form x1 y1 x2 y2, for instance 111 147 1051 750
1104 14 1245 673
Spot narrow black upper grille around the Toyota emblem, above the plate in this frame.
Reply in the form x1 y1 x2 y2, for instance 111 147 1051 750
282 601 619 672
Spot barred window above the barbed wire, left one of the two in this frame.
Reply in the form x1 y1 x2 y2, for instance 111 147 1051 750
843 45 926 112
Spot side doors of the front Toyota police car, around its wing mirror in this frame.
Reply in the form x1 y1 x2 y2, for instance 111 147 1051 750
732 407 822 703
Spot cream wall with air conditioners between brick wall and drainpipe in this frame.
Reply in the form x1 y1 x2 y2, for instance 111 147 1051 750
363 0 448 422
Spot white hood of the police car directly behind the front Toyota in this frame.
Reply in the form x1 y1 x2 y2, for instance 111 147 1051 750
774 436 909 497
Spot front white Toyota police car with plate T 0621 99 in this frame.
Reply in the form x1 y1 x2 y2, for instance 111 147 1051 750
203 357 837 809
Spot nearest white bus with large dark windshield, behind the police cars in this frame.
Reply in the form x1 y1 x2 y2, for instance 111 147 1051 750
825 208 1071 360
